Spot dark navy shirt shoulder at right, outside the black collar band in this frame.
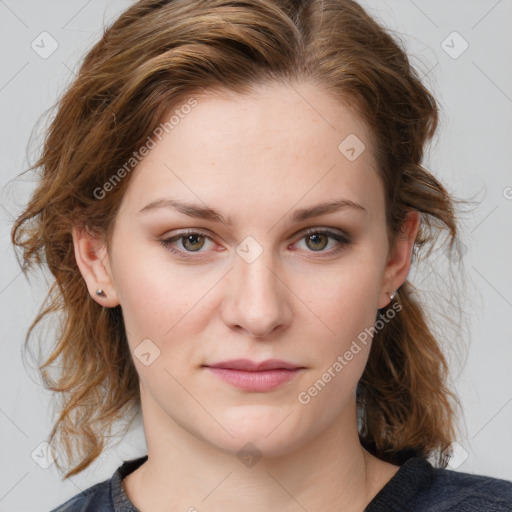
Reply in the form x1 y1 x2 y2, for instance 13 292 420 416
414 462 512 512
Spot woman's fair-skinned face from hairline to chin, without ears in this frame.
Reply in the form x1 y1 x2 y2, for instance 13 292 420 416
96 83 402 454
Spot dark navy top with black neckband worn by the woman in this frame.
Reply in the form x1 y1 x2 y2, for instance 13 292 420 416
51 455 512 512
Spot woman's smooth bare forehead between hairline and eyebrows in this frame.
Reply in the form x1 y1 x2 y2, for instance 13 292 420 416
123 83 383 221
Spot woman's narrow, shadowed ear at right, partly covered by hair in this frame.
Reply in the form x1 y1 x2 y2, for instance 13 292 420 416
377 211 420 309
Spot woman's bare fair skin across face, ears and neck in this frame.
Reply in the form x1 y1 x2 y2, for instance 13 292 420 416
73 82 419 512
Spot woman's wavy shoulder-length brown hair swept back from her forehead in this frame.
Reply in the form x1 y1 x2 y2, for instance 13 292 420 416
11 0 464 478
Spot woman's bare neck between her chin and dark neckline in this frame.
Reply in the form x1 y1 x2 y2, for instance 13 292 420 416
123 390 398 512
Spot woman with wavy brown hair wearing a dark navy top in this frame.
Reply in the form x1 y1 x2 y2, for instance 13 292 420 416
13 0 512 512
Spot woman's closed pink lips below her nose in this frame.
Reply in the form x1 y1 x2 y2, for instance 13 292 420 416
206 359 304 392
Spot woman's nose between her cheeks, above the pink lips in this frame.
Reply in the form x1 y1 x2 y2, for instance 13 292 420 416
221 251 292 338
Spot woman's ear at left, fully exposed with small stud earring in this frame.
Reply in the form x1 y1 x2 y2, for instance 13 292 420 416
72 227 119 308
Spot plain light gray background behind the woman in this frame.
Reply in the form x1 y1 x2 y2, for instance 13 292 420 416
0 0 512 512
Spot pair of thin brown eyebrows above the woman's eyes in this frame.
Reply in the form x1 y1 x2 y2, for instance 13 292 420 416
139 199 366 226
